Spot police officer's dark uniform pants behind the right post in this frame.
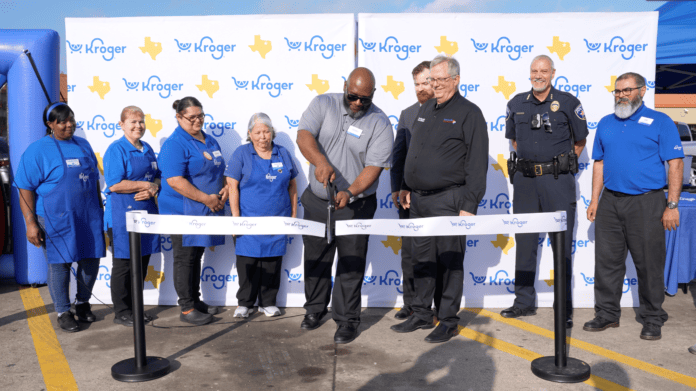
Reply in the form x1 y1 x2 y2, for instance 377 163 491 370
512 172 576 315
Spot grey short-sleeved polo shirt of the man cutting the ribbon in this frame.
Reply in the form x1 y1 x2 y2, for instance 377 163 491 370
298 93 394 199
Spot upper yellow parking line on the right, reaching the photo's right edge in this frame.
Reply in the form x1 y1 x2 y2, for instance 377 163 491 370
464 308 696 388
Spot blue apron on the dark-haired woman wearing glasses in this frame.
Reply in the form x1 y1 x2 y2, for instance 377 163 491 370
183 136 225 247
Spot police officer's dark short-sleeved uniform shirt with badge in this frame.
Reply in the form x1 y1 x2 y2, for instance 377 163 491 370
505 87 589 163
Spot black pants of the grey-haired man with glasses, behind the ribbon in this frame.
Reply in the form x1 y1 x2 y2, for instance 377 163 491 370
411 187 466 327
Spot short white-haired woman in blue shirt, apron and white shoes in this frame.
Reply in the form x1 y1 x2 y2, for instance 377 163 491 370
225 113 297 318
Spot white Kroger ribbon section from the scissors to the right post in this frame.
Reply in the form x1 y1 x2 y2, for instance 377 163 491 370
336 211 567 236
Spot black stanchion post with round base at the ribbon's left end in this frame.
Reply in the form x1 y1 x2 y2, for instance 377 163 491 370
111 232 170 382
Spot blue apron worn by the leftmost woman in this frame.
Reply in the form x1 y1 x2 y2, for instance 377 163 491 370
44 136 106 263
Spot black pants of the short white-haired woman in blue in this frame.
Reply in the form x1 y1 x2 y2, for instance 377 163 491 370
237 255 283 307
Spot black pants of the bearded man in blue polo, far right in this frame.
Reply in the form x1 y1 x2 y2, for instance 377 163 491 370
594 191 667 326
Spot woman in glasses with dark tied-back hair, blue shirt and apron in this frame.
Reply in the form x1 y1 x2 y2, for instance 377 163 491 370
158 96 228 325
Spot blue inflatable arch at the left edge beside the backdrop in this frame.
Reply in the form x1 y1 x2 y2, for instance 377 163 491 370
0 29 60 285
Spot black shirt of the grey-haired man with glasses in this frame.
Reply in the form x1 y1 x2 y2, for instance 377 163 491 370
404 91 488 213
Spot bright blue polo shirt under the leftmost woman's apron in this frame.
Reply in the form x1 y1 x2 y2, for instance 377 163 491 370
14 136 97 216
